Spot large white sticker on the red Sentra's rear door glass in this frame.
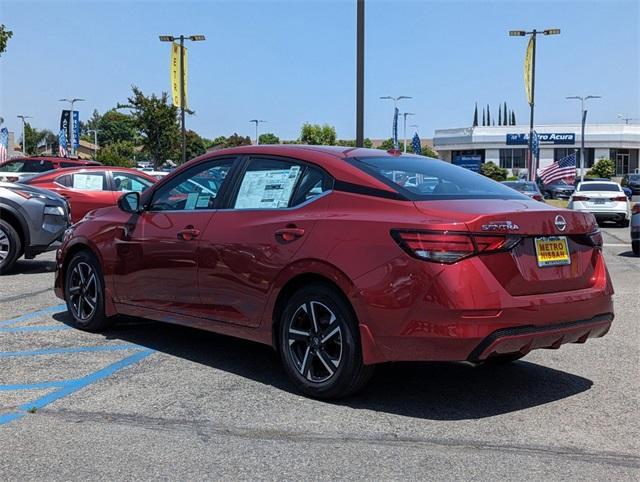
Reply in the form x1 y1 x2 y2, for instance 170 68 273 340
234 166 300 209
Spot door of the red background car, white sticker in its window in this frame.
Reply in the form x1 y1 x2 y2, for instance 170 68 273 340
54 169 117 223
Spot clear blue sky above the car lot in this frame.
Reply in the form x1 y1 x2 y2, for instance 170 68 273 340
0 0 640 139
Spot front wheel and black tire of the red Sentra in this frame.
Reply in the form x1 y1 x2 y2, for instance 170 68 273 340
64 251 113 331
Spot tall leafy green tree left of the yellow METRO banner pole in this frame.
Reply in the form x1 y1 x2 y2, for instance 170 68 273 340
117 86 180 167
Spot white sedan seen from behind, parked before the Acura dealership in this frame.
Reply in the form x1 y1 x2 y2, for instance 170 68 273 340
568 181 631 227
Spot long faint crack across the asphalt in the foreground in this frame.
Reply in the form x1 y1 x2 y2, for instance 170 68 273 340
38 409 640 468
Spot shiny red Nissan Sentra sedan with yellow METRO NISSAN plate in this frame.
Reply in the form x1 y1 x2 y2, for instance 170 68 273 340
55 146 613 398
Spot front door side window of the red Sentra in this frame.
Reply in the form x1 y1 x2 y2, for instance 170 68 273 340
149 159 234 211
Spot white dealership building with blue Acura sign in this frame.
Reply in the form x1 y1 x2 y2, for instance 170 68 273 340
433 124 640 176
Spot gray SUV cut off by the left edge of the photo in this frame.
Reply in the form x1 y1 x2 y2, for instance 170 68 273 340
0 182 69 275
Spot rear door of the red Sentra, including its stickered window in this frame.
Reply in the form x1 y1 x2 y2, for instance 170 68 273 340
198 157 331 326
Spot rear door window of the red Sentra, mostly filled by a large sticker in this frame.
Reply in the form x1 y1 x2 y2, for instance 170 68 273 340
233 158 304 209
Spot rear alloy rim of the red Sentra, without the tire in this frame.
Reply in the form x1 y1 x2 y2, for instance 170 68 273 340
287 301 343 383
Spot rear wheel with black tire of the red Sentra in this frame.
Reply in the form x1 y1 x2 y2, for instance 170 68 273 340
279 284 374 399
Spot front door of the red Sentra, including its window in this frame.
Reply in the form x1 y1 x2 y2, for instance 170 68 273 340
115 158 234 315
